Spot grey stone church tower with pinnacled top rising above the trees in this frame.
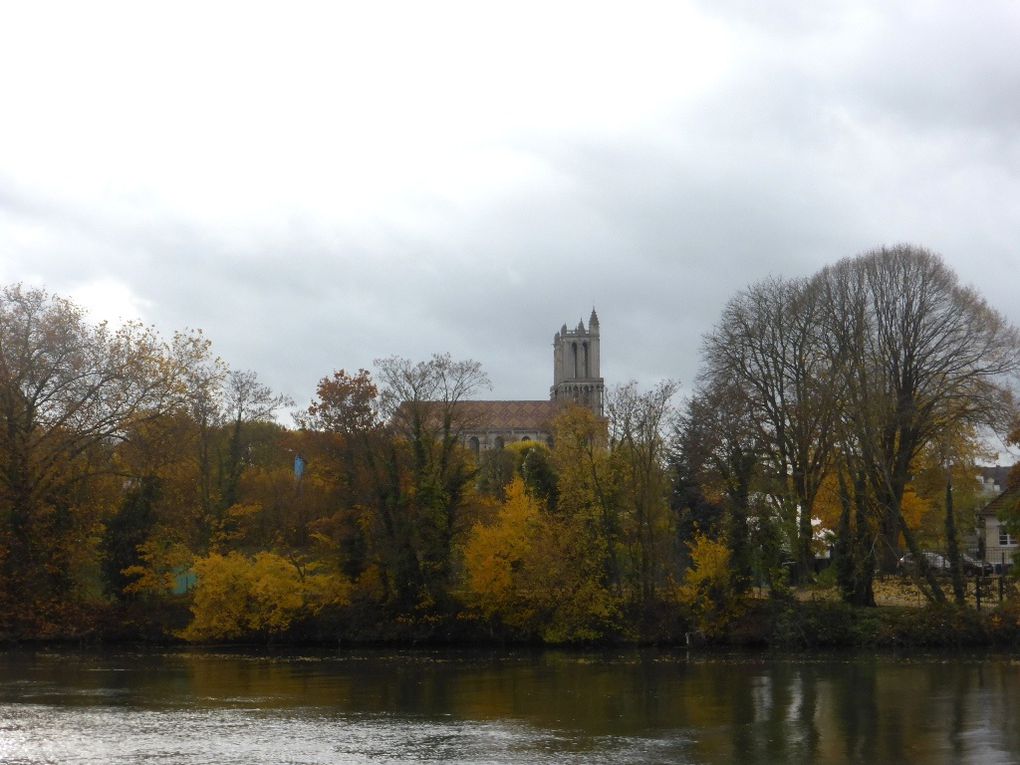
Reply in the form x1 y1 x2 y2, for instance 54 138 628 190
549 308 606 417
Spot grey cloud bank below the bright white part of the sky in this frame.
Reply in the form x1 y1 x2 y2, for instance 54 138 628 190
0 2 1020 416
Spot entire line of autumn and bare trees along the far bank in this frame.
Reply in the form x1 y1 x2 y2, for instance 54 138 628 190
0 247 1020 642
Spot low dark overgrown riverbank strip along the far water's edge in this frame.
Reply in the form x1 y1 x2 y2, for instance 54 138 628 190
0 583 1020 651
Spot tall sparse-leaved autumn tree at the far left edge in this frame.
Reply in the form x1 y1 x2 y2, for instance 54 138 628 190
0 285 187 629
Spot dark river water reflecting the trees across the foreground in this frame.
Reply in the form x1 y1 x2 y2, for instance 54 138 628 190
0 650 1020 765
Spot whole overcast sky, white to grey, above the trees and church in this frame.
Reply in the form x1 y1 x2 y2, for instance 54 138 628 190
0 0 1020 416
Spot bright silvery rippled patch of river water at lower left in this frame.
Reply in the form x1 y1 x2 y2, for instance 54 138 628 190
0 704 690 765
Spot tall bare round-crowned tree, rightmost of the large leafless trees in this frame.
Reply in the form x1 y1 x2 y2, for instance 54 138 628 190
814 245 1020 600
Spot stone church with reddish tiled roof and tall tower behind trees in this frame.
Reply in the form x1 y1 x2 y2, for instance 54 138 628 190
458 308 606 454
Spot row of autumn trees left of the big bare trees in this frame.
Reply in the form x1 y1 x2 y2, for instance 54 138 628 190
0 286 676 640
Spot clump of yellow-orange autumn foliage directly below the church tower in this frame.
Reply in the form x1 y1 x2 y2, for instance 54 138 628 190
464 406 625 643
